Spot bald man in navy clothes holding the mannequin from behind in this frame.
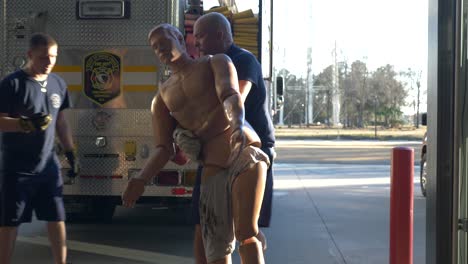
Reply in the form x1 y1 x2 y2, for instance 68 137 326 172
192 12 275 263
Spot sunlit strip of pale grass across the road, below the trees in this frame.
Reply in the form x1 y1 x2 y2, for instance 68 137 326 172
275 126 426 141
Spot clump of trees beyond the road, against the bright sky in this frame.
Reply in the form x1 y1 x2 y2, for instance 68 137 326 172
306 60 412 128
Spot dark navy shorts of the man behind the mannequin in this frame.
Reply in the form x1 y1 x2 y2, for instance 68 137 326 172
192 145 274 227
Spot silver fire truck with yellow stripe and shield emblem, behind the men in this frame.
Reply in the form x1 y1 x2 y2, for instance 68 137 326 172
0 0 272 221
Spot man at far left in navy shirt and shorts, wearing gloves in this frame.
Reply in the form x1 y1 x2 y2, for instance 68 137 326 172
0 33 77 263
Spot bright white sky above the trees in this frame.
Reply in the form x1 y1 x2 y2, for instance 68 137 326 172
204 0 428 113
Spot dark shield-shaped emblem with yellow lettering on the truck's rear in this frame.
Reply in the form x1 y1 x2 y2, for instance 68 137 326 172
84 52 122 105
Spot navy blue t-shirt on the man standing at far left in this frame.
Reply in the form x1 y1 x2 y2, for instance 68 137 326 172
0 70 70 173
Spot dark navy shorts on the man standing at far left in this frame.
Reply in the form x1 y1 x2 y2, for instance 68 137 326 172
0 157 65 226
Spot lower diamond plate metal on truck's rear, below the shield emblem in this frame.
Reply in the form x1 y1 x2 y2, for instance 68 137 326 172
62 109 197 196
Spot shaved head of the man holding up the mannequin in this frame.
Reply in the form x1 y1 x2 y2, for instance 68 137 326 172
194 12 233 54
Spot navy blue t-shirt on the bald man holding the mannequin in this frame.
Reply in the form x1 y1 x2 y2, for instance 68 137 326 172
226 45 275 148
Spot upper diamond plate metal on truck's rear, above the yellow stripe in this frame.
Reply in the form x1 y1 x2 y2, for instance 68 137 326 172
1 0 184 75
